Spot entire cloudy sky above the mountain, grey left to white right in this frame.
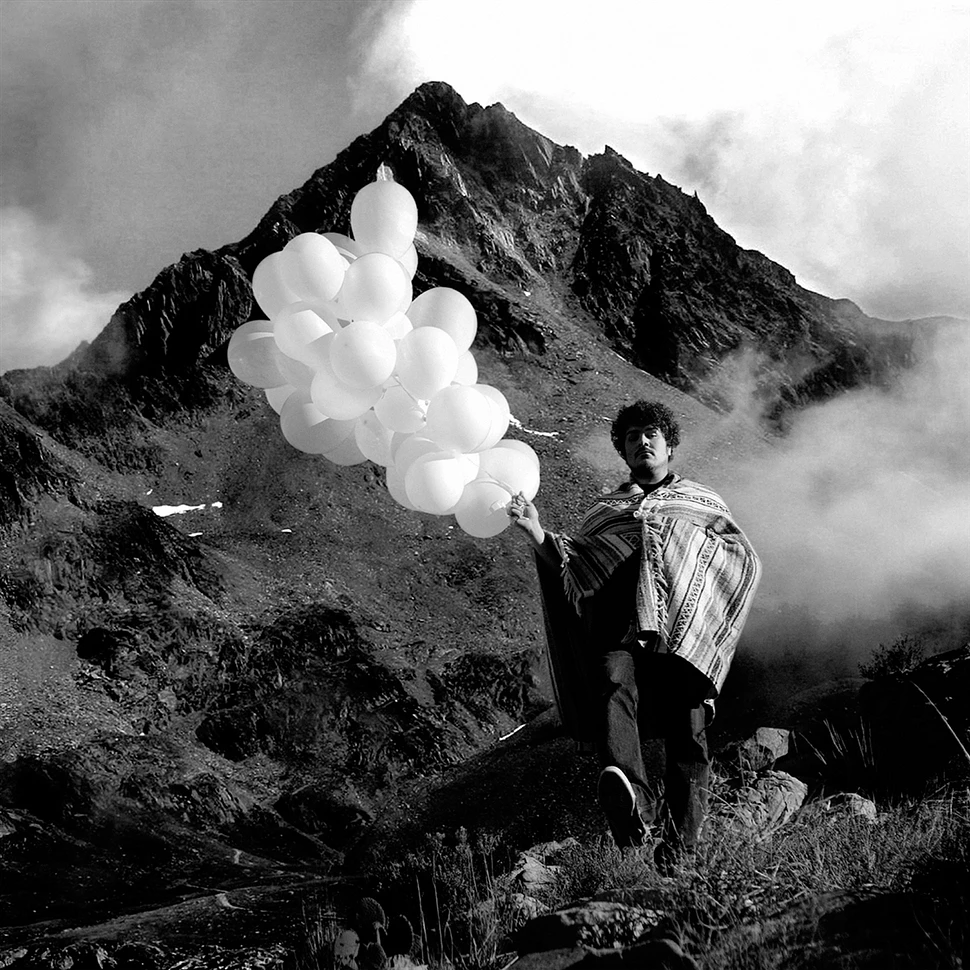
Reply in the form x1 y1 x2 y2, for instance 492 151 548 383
0 0 970 372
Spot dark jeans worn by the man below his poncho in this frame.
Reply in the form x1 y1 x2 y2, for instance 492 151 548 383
599 644 711 849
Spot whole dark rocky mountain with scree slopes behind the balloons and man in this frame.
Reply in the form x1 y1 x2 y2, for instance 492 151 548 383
0 84 960 951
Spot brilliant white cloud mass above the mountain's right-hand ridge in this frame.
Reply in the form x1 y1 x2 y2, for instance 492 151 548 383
367 0 970 319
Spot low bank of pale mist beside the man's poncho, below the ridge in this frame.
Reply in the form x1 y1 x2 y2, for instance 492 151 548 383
729 321 970 642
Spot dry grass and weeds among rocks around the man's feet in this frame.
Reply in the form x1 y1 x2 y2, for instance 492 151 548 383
320 792 970 970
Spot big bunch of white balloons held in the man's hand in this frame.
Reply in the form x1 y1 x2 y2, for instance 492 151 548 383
229 173 539 538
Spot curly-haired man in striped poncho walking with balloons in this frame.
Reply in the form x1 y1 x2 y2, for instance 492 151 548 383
508 401 761 866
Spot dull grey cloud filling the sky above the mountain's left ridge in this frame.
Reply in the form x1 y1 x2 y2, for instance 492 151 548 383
0 0 393 300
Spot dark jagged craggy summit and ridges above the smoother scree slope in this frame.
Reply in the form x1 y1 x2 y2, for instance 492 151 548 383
3 81 920 432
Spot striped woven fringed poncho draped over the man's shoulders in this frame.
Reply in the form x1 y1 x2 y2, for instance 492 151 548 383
537 475 761 740
